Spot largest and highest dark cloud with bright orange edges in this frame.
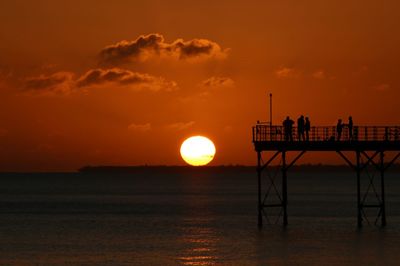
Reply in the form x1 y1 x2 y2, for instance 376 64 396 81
99 33 228 65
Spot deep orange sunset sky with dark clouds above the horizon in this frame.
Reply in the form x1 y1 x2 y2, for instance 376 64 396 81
0 0 400 171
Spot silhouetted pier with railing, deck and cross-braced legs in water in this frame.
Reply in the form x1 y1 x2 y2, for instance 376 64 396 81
252 123 400 227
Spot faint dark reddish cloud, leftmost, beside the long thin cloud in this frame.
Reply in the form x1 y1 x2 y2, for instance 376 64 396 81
25 71 74 94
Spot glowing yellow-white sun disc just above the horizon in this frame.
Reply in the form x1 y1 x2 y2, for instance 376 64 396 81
181 136 215 166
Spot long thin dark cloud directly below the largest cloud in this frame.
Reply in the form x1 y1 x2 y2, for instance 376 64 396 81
76 68 177 91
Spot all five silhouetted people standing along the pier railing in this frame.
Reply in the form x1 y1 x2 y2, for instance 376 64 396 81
282 115 353 141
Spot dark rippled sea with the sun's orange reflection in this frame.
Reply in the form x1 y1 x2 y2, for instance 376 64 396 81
0 170 400 265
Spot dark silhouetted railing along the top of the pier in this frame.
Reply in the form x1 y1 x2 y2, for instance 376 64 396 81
253 124 400 142
